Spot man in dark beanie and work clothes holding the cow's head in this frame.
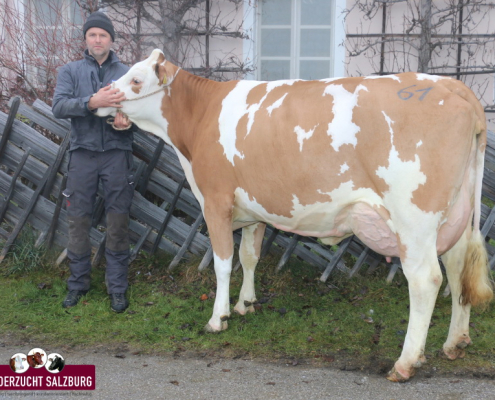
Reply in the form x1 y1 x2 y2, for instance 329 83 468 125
52 12 134 312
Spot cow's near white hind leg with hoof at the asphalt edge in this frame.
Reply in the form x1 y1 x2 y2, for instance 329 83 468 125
387 245 442 382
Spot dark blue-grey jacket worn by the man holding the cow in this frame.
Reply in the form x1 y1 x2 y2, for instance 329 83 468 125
52 50 133 151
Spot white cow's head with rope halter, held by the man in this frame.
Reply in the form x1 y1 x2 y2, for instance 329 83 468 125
96 49 178 141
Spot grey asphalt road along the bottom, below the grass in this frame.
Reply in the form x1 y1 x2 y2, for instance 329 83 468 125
0 343 495 400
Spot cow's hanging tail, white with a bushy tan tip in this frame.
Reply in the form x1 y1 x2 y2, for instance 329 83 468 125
461 99 493 307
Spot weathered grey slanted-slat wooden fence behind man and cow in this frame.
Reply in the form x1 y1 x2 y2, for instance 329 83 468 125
0 98 495 281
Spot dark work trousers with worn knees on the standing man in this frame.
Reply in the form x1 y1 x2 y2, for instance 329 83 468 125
64 149 134 294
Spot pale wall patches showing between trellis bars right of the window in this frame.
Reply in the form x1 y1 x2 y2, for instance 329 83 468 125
346 0 495 130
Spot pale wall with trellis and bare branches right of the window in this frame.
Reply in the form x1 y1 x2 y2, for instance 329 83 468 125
346 0 495 129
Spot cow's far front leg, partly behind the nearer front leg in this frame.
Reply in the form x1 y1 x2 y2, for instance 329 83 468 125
234 223 266 315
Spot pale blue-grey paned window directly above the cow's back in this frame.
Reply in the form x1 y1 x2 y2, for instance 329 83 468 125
258 0 334 81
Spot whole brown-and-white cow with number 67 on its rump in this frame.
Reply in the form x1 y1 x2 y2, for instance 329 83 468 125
97 49 493 381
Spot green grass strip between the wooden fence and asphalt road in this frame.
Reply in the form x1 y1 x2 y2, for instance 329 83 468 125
0 230 495 372
